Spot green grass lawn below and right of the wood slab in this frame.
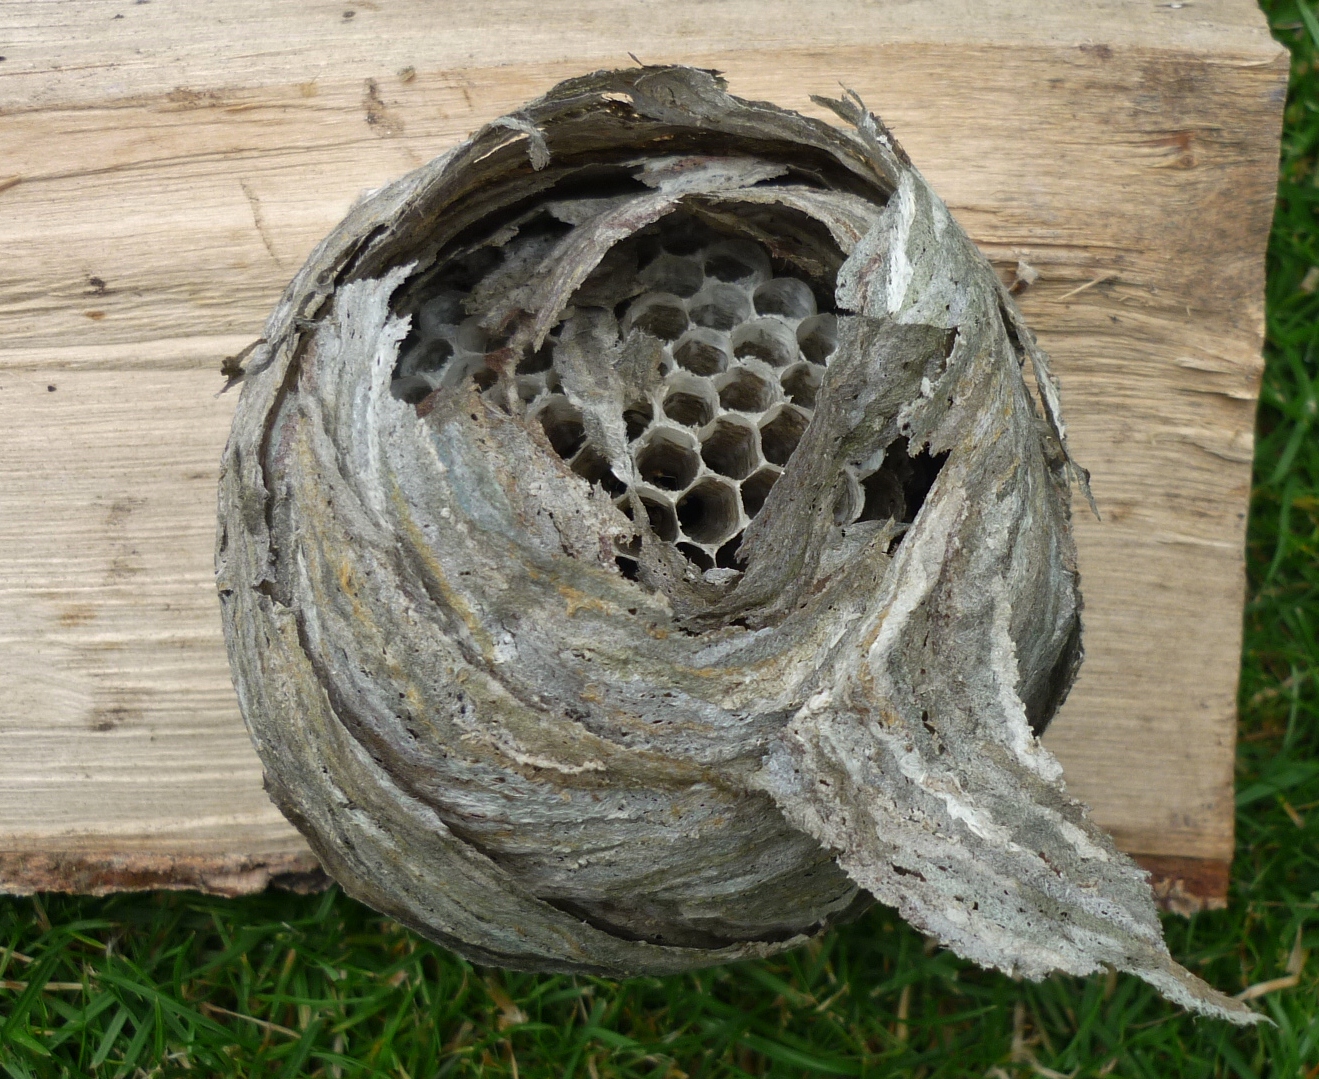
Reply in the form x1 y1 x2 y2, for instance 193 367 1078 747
0 0 1319 1079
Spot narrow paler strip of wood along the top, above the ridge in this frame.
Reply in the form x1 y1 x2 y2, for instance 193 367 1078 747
0 0 1278 108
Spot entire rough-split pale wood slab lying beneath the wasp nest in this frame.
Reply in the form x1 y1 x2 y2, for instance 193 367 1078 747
0 0 1286 902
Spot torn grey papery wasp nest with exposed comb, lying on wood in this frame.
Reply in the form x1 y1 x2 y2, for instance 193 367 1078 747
216 67 1254 1021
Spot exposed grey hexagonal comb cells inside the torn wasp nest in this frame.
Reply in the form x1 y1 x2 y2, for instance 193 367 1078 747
392 214 855 582
